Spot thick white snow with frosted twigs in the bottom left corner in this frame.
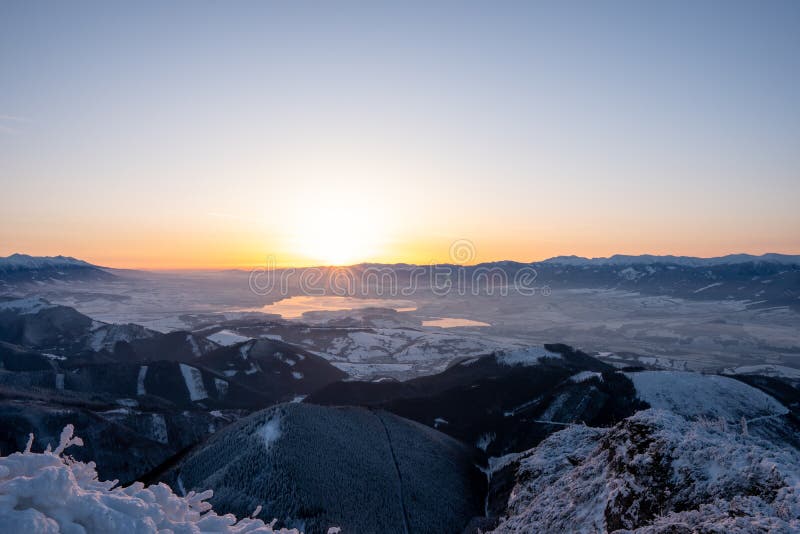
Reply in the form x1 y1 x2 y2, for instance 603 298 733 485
0 425 298 534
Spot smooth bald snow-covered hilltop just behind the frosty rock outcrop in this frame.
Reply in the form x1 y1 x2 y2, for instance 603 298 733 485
625 371 789 422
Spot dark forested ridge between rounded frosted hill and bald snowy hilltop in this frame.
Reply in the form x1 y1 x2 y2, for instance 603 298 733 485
306 345 645 456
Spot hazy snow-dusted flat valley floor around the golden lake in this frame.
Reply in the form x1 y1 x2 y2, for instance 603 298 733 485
15 272 800 382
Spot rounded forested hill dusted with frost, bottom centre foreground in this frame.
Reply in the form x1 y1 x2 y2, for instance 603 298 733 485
160 404 485 533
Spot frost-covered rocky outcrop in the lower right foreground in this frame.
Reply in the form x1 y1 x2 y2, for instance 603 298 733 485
495 410 800 532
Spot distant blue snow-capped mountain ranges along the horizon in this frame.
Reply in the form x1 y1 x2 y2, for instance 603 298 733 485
6 254 800 311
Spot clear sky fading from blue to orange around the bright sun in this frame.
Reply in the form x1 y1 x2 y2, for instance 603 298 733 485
0 0 800 268
